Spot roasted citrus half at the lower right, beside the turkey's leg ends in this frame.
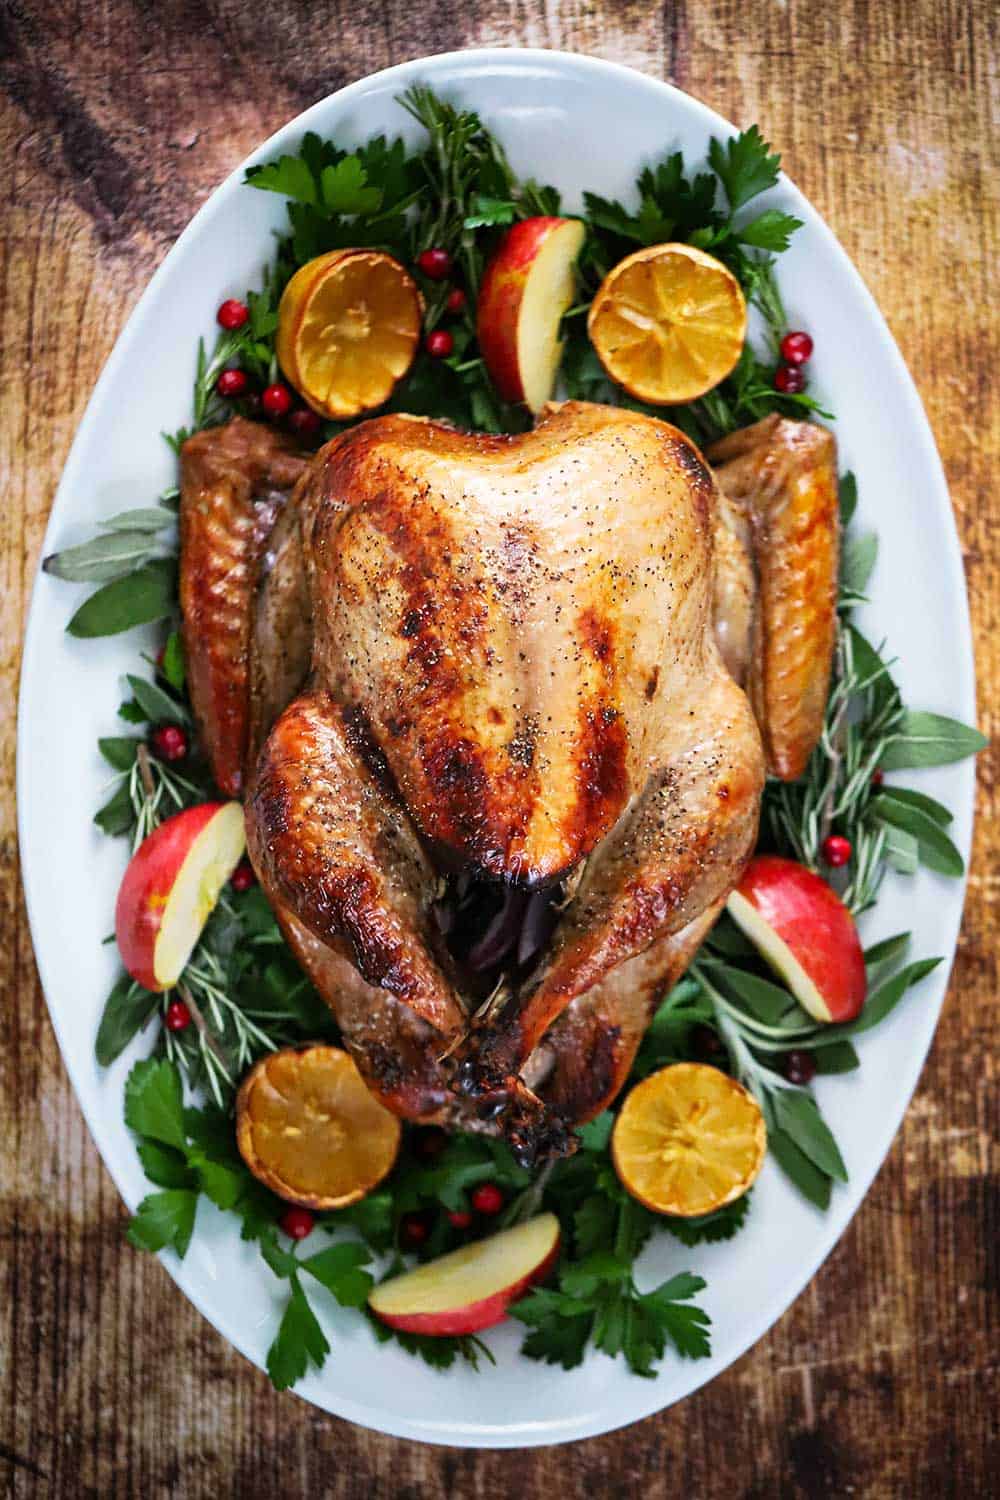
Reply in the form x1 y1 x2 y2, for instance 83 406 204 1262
612 1062 768 1218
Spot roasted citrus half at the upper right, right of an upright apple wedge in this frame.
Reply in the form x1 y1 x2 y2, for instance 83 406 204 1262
586 245 747 405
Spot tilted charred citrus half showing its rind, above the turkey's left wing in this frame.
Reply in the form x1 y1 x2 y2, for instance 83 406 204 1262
276 251 423 420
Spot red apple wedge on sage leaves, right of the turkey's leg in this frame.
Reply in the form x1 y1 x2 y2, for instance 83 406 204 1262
726 855 868 1022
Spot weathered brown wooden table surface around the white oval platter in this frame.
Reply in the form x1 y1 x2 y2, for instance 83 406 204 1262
0 0 1000 1500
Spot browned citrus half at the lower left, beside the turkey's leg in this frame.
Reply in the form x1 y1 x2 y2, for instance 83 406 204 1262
237 1044 400 1209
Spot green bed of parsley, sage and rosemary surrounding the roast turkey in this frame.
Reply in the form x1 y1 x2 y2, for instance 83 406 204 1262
45 87 985 1389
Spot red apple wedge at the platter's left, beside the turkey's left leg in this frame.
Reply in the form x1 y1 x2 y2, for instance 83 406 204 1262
114 803 246 990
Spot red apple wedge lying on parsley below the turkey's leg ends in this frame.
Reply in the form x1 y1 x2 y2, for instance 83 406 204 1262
369 1214 559 1335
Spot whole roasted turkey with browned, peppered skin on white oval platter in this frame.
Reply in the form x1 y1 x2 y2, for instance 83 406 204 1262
181 402 837 1160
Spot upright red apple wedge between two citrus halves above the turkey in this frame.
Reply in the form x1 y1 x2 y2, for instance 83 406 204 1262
477 218 585 413
